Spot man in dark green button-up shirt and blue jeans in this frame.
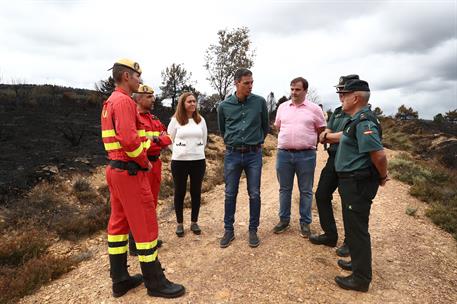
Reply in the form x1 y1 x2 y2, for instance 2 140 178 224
217 69 269 248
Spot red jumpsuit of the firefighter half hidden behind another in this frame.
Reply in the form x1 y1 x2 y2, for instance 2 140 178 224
140 112 171 207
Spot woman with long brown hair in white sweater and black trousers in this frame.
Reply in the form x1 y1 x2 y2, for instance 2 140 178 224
167 92 208 237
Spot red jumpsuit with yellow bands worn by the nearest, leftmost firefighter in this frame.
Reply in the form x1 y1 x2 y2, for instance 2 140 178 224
101 88 158 262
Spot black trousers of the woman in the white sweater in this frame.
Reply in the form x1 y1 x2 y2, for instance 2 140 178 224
171 159 206 223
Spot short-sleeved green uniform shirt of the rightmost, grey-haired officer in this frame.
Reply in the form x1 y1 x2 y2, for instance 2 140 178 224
335 106 383 172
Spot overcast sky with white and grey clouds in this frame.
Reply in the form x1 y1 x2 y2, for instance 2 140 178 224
0 0 457 118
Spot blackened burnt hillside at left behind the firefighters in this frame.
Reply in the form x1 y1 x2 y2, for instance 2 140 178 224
0 84 221 204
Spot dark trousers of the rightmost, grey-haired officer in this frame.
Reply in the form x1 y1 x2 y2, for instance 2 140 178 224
338 178 379 283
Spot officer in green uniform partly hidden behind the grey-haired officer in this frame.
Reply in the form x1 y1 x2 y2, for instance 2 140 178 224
309 75 359 257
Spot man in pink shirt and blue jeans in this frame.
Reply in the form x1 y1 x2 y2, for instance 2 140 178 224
273 77 326 237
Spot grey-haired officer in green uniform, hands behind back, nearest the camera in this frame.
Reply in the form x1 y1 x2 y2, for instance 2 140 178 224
335 80 387 292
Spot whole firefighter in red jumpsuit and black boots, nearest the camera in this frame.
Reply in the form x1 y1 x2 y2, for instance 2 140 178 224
101 59 185 298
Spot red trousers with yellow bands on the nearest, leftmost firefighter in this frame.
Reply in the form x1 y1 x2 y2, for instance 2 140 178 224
106 166 158 262
